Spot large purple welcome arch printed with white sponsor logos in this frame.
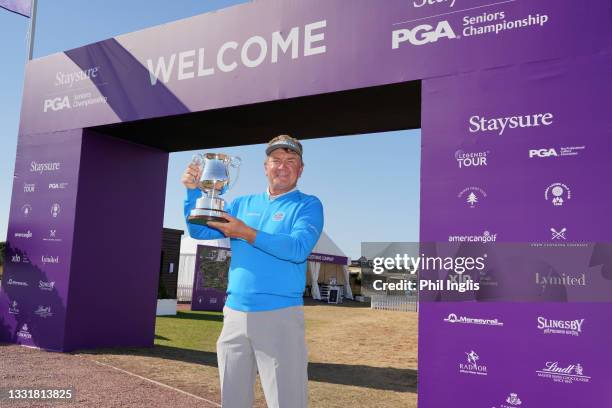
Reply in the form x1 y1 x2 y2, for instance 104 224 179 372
0 0 612 408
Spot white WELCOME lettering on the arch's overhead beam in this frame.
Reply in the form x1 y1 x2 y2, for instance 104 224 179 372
146 20 327 86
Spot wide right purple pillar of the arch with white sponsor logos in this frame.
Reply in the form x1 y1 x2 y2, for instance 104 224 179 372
419 55 612 408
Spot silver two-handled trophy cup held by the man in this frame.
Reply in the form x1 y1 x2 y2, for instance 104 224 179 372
188 153 241 225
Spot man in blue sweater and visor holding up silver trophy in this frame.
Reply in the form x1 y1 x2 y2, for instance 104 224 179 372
182 135 323 408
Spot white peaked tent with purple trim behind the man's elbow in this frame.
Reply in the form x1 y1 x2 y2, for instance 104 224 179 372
307 231 353 300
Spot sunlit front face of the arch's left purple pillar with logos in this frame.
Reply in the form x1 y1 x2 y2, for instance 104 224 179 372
0 130 82 350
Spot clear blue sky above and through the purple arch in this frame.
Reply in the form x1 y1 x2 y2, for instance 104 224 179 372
0 0 420 257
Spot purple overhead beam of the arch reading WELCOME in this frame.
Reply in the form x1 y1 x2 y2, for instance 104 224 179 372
20 0 612 134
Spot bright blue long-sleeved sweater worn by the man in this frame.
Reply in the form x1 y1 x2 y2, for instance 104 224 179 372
184 189 323 312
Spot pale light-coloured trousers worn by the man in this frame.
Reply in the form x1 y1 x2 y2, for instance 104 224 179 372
217 306 308 408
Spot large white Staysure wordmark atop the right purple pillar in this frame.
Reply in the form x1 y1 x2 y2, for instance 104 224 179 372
468 112 555 136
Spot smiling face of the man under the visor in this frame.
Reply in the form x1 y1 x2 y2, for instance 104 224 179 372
264 149 304 194
